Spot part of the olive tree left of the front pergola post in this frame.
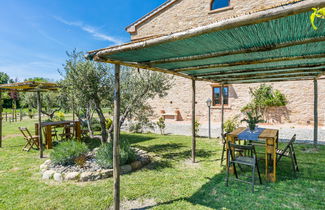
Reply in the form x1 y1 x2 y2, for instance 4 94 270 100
61 51 113 142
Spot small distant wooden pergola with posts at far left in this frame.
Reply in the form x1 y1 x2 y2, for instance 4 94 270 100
0 81 59 158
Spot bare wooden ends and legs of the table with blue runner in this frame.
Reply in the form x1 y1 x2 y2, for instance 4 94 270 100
226 127 279 182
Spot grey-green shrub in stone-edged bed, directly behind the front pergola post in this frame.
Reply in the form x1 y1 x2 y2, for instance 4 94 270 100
96 139 136 168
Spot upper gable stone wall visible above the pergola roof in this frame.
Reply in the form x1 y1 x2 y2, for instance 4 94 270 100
131 0 302 40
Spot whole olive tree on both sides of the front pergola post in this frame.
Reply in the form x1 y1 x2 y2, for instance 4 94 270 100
61 51 173 142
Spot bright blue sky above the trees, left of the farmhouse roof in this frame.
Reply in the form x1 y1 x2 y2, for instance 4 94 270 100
0 0 165 80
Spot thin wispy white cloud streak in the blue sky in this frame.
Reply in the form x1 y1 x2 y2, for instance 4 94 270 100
54 16 123 45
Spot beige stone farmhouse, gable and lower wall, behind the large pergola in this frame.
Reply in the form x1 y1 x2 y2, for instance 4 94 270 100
126 0 325 125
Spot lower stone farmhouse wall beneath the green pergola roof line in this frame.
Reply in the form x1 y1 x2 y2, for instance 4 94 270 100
150 77 325 125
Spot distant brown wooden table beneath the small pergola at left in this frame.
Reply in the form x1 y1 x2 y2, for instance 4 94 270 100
35 120 81 149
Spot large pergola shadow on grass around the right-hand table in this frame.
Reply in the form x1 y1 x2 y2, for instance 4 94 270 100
136 146 325 209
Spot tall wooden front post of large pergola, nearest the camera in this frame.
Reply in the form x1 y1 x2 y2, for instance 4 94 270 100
113 64 121 210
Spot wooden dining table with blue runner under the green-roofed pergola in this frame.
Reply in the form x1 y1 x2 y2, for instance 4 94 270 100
226 127 279 182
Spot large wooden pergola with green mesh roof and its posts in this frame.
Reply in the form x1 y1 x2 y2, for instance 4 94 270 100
87 0 325 209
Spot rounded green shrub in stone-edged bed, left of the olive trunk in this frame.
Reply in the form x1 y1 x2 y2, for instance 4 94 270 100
50 140 88 165
